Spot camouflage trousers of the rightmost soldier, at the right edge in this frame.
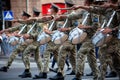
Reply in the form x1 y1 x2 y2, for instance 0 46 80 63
99 38 120 80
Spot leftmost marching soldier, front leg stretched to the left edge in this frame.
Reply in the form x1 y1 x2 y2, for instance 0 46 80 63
0 12 30 72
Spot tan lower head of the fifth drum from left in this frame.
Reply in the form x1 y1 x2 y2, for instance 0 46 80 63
72 32 87 44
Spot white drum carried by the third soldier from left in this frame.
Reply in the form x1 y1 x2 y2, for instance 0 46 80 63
37 32 51 45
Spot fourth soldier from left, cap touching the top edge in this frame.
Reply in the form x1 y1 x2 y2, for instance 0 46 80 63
50 0 76 80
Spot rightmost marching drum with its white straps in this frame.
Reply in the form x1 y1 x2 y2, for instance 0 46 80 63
92 11 116 47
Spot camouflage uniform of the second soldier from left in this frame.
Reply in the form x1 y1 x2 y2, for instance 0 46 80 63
22 23 43 71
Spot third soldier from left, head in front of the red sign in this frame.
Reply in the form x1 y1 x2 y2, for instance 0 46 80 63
31 4 59 79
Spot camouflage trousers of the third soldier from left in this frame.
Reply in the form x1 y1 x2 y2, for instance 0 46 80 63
43 42 60 72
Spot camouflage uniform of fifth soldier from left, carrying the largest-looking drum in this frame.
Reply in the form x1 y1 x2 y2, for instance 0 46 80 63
69 11 99 79
